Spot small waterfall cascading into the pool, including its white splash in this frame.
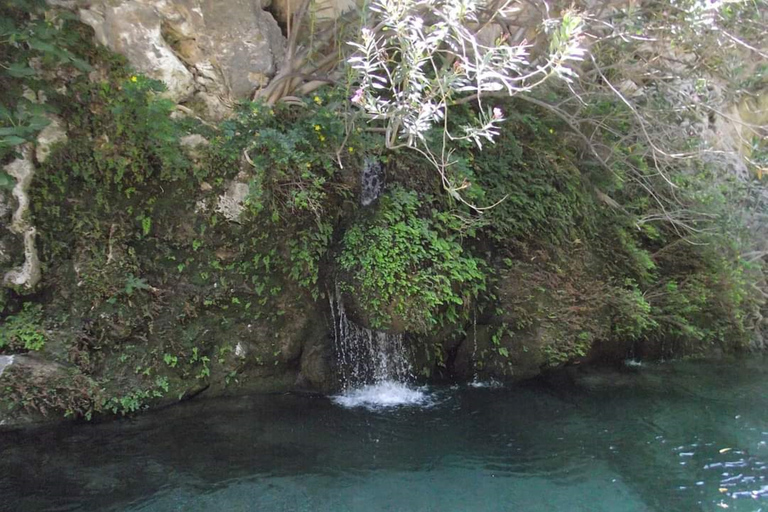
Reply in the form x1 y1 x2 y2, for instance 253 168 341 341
328 285 428 409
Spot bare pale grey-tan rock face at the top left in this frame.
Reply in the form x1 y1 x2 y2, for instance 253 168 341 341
79 0 285 119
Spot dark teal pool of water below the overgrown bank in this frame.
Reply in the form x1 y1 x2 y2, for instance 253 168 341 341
0 358 768 512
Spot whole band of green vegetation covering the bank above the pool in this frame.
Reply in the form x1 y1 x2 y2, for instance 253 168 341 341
0 0 765 418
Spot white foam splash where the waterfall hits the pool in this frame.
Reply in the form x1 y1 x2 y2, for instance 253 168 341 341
331 380 432 410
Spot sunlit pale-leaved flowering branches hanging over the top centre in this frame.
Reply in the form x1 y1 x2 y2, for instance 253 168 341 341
349 0 585 206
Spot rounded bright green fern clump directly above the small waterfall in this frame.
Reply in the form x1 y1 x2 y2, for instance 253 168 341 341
339 187 486 332
